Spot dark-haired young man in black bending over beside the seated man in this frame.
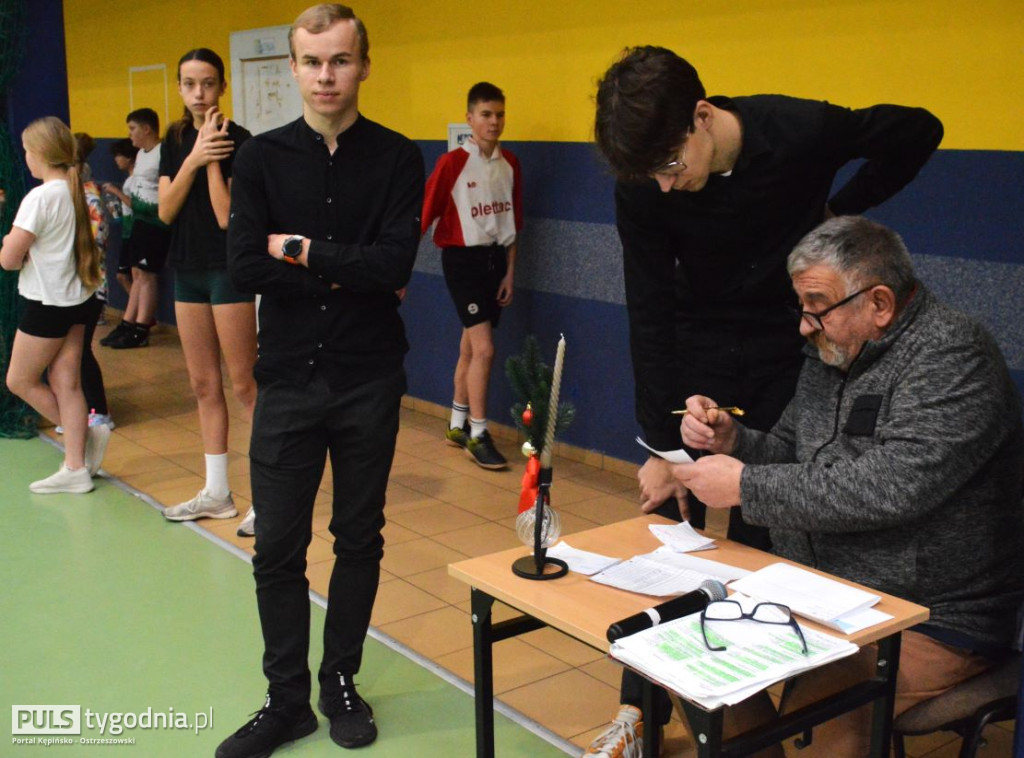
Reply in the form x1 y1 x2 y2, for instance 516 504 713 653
588 47 942 756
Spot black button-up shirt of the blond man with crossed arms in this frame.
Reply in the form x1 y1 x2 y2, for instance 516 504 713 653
227 116 424 388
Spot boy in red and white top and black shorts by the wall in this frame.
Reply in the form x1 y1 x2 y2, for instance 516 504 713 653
422 82 522 469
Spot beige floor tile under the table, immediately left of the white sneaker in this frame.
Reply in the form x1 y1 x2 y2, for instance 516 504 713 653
501 669 618 734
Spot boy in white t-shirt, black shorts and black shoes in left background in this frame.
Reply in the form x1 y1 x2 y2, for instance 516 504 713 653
100 108 171 349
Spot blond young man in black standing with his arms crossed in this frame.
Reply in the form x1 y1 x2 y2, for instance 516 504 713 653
217 4 424 758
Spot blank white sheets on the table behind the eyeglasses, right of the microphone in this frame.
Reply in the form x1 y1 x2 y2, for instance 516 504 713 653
732 563 882 632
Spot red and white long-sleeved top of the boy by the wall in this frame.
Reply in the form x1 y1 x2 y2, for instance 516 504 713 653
420 140 522 248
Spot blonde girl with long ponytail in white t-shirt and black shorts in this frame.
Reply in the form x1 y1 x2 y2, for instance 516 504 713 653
0 117 110 495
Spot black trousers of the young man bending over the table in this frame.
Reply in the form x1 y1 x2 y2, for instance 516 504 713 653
620 324 805 724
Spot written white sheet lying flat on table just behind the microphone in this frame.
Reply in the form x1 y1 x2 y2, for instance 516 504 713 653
591 545 750 597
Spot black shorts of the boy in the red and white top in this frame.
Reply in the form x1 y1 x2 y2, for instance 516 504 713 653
441 245 508 329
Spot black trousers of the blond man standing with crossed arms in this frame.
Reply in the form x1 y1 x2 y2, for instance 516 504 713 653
249 369 406 705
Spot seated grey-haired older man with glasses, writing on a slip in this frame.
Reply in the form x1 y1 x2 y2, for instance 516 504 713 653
674 216 1024 757
